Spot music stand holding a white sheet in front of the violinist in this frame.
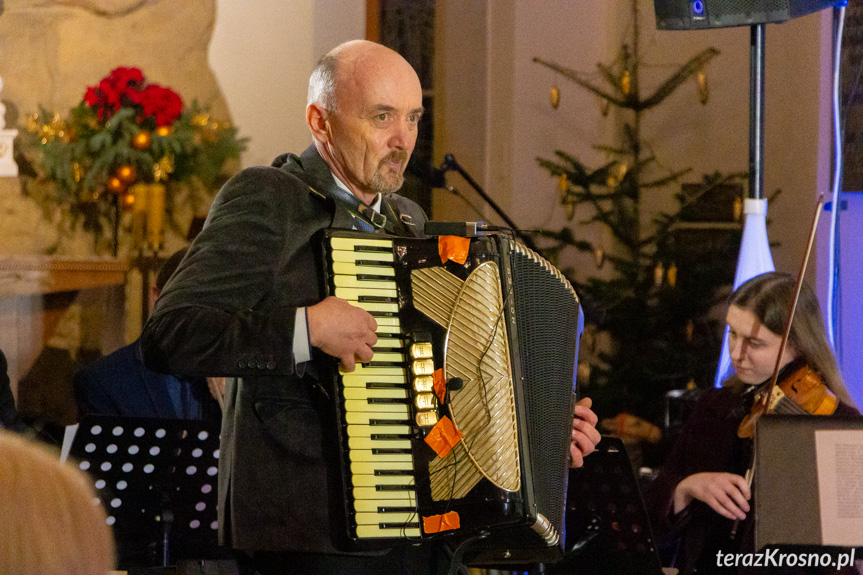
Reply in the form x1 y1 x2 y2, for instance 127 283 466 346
753 415 863 550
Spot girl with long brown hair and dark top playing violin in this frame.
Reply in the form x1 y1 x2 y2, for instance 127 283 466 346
645 273 859 575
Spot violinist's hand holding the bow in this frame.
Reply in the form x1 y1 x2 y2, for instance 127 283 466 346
674 473 752 519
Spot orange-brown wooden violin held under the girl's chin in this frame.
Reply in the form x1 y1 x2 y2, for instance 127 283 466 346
737 359 839 438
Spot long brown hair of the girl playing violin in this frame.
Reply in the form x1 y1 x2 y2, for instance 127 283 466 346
730 272 857 407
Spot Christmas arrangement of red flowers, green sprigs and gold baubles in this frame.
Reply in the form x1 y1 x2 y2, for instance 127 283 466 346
22 67 246 254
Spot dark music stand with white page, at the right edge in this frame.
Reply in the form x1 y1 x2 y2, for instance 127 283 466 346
753 415 863 552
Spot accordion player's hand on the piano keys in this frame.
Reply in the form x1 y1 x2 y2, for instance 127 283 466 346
306 296 378 371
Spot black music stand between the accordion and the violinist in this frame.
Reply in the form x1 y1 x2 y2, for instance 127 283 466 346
550 435 662 575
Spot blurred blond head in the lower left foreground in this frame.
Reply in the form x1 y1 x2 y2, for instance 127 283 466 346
0 431 115 575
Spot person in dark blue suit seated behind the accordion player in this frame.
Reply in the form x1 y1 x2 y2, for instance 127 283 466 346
74 248 225 422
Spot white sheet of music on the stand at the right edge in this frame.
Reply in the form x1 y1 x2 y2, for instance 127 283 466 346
815 429 863 547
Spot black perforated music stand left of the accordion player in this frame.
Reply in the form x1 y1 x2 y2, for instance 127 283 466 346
69 415 219 568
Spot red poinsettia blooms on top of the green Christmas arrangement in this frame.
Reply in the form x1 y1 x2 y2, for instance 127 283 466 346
84 67 183 127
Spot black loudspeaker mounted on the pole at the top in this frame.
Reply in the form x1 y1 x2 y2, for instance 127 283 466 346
653 0 842 30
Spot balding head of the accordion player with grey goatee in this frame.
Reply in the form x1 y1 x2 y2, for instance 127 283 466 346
306 40 423 203
